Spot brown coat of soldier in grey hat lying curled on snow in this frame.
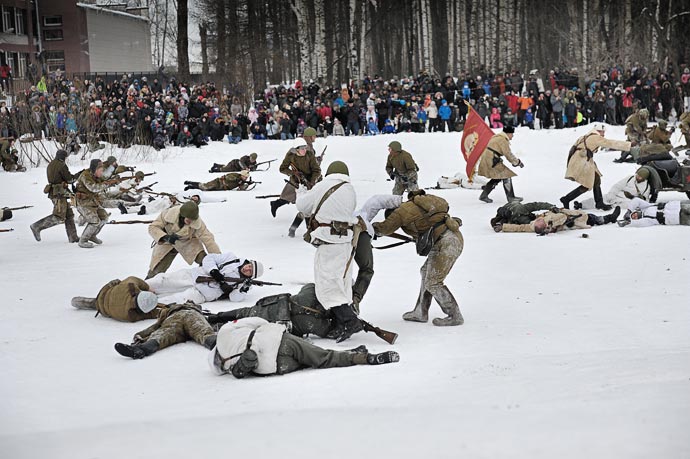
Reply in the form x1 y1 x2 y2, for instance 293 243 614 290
96 276 160 322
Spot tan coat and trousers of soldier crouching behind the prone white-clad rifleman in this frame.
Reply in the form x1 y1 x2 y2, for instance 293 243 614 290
147 205 220 279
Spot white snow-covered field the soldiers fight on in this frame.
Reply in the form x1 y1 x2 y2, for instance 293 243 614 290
0 127 690 459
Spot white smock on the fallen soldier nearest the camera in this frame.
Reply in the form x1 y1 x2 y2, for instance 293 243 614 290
209 317 285 375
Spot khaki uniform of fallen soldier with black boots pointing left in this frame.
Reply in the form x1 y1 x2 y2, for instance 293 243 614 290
134 303 216 350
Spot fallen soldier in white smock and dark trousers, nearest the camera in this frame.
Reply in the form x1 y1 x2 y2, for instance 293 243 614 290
208 317 400 379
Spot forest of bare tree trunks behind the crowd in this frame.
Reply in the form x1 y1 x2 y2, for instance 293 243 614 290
151 0 690 91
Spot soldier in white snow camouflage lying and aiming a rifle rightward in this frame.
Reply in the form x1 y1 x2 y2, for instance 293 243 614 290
146 252 264 304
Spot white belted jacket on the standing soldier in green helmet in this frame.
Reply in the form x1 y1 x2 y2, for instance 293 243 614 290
296 174 357 244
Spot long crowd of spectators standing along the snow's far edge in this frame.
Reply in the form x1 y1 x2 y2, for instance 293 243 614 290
0 64 690 149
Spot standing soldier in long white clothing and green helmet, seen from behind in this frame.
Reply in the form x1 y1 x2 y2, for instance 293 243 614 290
296 161 362 341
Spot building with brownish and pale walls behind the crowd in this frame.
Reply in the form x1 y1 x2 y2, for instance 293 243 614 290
0 0 152 81
